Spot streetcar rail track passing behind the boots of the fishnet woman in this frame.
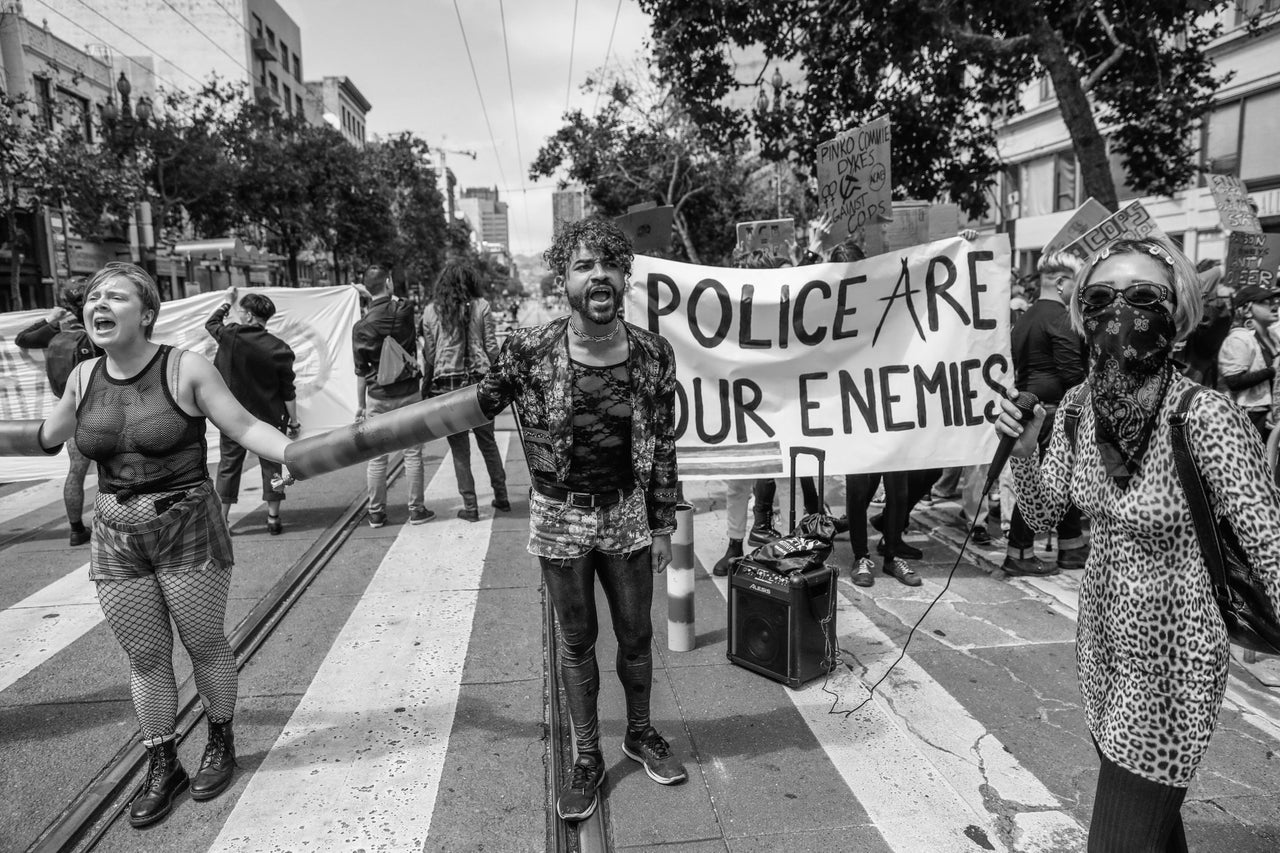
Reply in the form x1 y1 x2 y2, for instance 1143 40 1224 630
27 457 403 853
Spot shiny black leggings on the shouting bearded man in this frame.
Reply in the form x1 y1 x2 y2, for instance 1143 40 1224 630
539 547 653 753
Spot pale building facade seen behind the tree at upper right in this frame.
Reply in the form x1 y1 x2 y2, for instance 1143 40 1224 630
987 6 1280 273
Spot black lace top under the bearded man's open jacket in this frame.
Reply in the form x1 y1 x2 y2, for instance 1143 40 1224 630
552 360 635 492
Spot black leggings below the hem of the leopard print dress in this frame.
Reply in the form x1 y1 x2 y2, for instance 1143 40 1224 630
1088 743 1187 853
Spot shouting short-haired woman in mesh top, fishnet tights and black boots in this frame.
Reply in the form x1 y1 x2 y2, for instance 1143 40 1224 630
13 264 288 826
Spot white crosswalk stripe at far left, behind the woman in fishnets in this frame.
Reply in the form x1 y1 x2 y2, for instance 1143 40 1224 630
0 465 262 690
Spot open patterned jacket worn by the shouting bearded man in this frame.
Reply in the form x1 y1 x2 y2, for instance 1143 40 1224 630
480 316 677 535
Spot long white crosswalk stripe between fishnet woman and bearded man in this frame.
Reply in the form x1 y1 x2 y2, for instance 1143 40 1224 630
211 433 509 852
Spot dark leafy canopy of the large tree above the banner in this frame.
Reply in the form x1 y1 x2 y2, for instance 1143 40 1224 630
640 0 1231 216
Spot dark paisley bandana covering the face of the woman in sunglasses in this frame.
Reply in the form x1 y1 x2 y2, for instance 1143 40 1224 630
1084 298 1176 487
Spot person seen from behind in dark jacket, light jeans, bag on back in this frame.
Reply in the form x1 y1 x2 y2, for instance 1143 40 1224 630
351 264 435 528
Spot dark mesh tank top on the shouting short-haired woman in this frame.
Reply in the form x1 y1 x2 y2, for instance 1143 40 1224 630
76 346 209 501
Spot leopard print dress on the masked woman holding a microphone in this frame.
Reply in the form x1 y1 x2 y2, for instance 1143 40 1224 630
1012 377 1280 788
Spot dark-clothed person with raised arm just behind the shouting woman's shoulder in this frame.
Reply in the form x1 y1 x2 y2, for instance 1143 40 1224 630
205 287 301 537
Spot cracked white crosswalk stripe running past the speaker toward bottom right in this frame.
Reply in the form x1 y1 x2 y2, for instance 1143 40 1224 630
686 480 1084 853
